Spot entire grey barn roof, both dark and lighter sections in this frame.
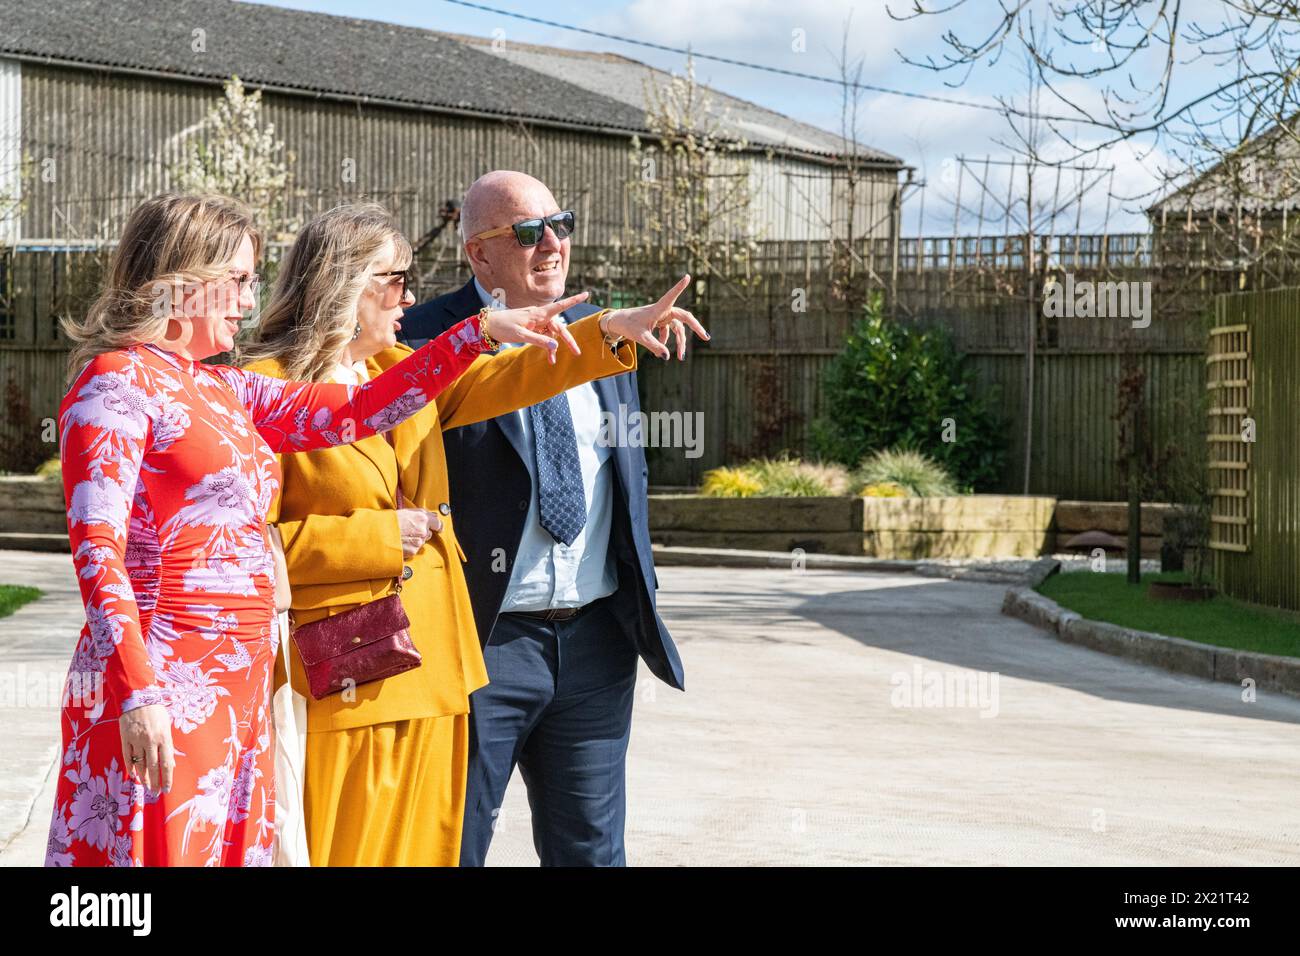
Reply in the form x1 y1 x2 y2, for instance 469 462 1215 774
0 0 901 165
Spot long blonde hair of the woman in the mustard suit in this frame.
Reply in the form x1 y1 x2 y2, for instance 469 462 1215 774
239 203 412 381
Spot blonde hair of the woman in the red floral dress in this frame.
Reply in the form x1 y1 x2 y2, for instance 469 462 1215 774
60 194 261 385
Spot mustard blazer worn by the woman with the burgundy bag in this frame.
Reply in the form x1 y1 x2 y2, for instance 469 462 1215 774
248 312 637 732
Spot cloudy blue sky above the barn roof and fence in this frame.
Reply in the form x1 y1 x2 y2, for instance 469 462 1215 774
248 0 1232 234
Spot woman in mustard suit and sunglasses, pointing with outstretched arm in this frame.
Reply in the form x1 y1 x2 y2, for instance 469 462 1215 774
243 204 693 866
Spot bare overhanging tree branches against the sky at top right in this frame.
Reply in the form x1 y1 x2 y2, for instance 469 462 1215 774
889 0 1300 193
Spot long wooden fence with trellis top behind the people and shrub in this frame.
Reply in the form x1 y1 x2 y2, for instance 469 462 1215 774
0 235 1238 499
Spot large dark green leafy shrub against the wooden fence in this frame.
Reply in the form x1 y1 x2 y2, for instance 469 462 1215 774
813 295 1006 490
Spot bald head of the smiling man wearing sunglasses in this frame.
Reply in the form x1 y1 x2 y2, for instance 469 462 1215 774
460 169 569 308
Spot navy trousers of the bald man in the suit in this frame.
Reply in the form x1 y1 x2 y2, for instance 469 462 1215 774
460 598 637 866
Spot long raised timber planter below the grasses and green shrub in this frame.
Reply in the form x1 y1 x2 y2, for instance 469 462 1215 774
650 494 1056 559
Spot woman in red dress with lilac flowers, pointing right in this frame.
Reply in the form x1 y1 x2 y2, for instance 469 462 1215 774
46 196 584 866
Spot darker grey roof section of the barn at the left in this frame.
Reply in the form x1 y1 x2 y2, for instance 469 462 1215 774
0 0 644 130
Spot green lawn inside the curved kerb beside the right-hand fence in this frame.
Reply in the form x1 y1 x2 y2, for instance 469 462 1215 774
1039 571 1300 657
